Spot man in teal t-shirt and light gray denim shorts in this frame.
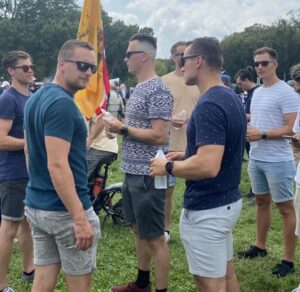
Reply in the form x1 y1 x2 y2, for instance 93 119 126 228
24 40 100 292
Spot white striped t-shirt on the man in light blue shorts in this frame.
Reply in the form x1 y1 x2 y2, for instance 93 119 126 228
250 80 300 162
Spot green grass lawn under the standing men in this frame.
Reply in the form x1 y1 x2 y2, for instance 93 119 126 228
5 154 300 292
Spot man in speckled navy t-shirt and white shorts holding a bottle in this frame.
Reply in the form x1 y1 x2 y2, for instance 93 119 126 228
150 37 247 292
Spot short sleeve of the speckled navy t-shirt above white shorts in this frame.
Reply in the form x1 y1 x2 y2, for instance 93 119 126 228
193 102 227 147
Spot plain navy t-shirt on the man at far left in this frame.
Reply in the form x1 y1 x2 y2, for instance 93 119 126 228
0 87 28 181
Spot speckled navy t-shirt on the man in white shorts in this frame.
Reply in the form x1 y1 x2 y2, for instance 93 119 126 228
184 86 247 210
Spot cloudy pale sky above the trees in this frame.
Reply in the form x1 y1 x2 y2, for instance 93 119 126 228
77 0 300 58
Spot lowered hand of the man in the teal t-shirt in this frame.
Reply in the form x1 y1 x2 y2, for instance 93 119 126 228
74 218 94 250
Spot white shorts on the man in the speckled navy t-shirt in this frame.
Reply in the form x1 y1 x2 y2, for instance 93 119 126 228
180 200 242 278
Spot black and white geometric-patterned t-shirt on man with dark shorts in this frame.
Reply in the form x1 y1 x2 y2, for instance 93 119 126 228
121 77 173 175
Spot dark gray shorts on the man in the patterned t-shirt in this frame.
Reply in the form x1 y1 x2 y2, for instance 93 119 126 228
122 173 166 239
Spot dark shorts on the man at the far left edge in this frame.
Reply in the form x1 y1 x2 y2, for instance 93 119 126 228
0 179 28 221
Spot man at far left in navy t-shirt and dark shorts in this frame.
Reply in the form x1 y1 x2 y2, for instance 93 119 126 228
0 51 34 292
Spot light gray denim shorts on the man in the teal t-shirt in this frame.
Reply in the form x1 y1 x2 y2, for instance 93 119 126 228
25 206 100 276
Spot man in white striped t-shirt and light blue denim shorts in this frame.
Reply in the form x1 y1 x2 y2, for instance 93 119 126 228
238 47 300 277
